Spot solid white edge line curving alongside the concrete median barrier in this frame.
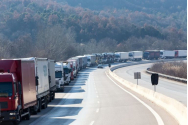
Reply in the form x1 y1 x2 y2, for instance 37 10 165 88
105 72 164 125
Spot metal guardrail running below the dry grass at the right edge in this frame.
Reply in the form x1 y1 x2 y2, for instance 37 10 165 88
146 70 187 84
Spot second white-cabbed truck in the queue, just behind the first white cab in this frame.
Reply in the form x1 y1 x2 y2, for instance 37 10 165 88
63 61 71 85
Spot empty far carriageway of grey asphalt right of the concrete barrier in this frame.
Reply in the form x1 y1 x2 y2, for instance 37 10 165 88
114 63 187 105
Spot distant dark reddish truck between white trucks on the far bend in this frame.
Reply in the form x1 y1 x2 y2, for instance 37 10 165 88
143 50 160 60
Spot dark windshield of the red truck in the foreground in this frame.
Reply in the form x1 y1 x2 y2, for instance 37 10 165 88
0 82 13 97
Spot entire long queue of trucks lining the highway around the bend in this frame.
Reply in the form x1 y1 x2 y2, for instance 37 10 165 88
0 50 187 125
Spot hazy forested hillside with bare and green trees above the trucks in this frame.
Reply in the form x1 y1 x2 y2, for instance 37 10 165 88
0 0 187 60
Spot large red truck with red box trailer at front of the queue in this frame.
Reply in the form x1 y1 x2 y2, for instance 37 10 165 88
0 60 38 125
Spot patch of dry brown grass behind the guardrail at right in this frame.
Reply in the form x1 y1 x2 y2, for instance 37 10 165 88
150 61 187 79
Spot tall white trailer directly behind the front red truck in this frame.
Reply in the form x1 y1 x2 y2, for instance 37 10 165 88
21 57 50 112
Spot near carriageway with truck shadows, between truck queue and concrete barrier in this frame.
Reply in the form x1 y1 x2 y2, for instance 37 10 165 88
0 64 178 125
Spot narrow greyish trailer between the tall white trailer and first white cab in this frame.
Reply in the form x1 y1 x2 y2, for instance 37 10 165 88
48 59 57 102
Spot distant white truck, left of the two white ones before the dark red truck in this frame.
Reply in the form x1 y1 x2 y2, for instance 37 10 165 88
114 52 129 62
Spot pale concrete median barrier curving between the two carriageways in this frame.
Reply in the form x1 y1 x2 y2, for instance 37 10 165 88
108 60 187 125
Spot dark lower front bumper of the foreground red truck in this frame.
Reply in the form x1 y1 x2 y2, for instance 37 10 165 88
0 111 17 122
